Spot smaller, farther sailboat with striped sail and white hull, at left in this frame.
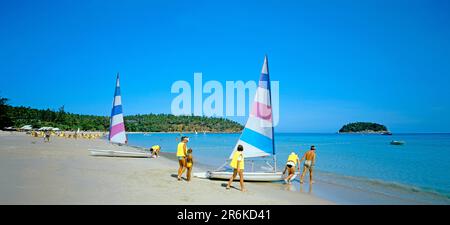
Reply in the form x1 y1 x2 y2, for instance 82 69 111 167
89 73 151 157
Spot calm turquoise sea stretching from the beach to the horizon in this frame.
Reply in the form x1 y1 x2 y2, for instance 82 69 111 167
128 133 450 204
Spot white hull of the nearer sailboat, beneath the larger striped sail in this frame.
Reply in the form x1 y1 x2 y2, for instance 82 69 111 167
207 171 283 182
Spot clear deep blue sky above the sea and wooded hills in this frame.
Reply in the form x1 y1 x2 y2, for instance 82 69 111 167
0 0 450 132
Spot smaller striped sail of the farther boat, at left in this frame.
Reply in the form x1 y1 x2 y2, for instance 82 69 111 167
109 74 127 144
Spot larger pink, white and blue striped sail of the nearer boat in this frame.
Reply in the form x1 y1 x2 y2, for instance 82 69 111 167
230 56 275 159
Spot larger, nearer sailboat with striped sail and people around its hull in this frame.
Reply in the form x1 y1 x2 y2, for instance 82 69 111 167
199 56 283 181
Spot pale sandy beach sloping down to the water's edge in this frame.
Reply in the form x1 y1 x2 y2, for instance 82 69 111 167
0 132 334 205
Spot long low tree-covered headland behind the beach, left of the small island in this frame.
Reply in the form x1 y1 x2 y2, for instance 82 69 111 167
0 97 243 133
